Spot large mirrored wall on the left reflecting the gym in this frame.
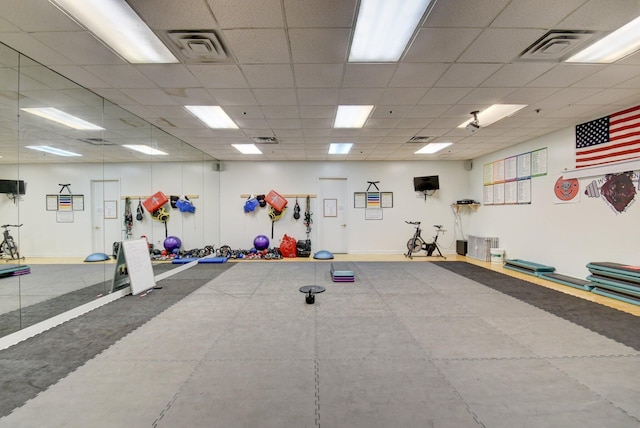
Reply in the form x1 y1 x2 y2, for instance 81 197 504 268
0 44 220 336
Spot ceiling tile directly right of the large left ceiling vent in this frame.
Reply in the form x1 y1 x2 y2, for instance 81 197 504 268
224 29 289 64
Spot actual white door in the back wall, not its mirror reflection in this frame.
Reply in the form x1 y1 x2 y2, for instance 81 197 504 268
312 178 349 254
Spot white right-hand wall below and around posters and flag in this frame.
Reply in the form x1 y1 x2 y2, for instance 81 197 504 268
468 128 640 279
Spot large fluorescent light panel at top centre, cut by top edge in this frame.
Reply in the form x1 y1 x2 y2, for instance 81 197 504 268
349 0 431 62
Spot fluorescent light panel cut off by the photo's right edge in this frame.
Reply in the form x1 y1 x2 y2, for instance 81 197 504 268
567 17 640 64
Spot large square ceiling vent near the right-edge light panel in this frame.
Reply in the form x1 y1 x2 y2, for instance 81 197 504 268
519 30 596 62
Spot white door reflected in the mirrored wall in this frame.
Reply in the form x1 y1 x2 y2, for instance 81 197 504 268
91 180 123 254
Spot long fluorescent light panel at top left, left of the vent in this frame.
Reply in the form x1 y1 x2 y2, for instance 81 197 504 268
49 0 179 64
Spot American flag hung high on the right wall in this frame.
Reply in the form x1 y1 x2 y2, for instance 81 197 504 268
576 106 640 168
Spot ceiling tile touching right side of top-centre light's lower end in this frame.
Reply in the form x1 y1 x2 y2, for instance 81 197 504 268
403 28 482 63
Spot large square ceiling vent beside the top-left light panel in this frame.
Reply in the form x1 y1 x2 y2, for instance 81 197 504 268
167 30 230 64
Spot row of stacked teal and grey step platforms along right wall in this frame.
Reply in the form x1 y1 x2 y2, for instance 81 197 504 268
504 259 640 305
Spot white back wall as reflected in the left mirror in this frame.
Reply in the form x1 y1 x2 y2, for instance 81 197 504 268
0 162 220 257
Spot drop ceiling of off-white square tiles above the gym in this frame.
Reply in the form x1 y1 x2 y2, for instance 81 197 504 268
0 0 640 161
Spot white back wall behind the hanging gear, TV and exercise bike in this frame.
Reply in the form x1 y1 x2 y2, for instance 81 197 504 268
220 161 469 254
